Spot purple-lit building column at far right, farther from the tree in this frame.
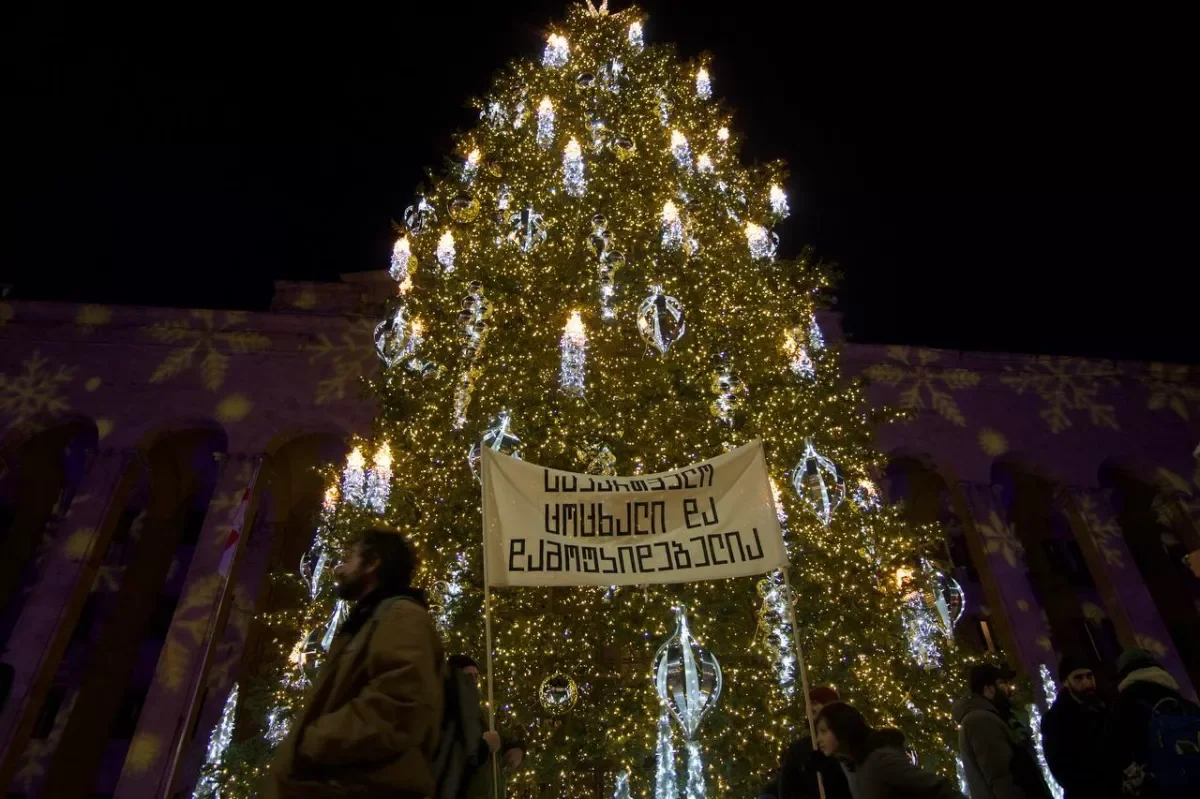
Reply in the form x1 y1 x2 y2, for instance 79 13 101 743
1067 488 1195 697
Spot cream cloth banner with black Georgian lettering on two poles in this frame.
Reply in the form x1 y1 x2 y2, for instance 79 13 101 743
482 441 787 585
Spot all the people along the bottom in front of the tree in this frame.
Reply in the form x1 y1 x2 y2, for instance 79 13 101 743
266 528 1200 799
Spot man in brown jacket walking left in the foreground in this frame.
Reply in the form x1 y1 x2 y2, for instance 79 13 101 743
265 528 444 799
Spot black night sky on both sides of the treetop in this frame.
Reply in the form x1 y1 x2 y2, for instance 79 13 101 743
7 0 1200 361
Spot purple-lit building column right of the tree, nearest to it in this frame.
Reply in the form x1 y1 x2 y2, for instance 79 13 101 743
959 482 1057 675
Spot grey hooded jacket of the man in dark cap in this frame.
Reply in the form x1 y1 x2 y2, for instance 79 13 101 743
950 693 1050 799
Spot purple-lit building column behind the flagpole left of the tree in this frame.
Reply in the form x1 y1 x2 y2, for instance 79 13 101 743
115 456 260 797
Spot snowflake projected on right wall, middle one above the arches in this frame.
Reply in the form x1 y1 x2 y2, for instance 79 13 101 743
1000 355 1121 433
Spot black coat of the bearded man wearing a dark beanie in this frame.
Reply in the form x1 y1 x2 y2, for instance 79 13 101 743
1042 690 1117 799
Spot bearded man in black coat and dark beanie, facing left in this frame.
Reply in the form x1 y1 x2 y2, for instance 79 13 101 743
1042 654 1116 799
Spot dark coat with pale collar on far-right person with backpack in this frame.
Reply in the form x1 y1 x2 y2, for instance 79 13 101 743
1106 668 1200 798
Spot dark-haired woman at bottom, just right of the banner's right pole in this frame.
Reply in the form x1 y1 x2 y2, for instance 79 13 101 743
817 702 965 799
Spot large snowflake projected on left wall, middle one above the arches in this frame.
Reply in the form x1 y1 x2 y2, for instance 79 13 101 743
143 310 271 391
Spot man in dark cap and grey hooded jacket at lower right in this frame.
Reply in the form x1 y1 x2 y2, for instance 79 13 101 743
950 663 1051 799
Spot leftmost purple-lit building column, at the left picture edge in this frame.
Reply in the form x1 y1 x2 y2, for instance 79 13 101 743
0 450 142 785
